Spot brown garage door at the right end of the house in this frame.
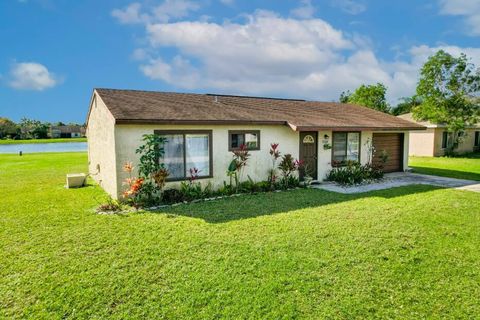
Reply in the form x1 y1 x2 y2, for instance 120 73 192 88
372 133 403 172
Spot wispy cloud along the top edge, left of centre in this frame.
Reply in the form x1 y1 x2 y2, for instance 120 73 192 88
112 0 200 24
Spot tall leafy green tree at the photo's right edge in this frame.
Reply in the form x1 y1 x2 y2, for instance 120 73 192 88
413 50 480 154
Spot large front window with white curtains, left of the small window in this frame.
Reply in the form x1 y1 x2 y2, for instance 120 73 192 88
155 131 212 180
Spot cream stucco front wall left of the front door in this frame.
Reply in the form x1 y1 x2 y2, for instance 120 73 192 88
115 124 299 195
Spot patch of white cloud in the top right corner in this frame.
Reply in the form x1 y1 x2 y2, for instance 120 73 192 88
440 0 480 36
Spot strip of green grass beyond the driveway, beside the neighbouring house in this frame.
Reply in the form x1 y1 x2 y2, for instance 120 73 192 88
409 153 480 181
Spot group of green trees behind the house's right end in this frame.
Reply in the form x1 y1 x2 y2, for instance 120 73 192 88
339 50 480 153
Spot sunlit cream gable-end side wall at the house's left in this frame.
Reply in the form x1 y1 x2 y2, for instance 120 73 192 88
86 94 117 198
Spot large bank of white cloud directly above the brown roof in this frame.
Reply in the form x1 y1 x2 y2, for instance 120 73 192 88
115 5 480 103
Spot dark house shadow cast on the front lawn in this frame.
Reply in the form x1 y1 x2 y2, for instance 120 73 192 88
159 185 441 223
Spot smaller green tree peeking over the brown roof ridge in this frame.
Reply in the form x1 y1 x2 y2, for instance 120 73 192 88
340 83 390 112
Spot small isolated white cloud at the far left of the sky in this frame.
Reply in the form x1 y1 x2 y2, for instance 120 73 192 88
9 62 59 91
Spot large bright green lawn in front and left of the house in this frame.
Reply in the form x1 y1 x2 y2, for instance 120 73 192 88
0 153 480 319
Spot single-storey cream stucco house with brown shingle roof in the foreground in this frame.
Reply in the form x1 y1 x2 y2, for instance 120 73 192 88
87 89 425 198
